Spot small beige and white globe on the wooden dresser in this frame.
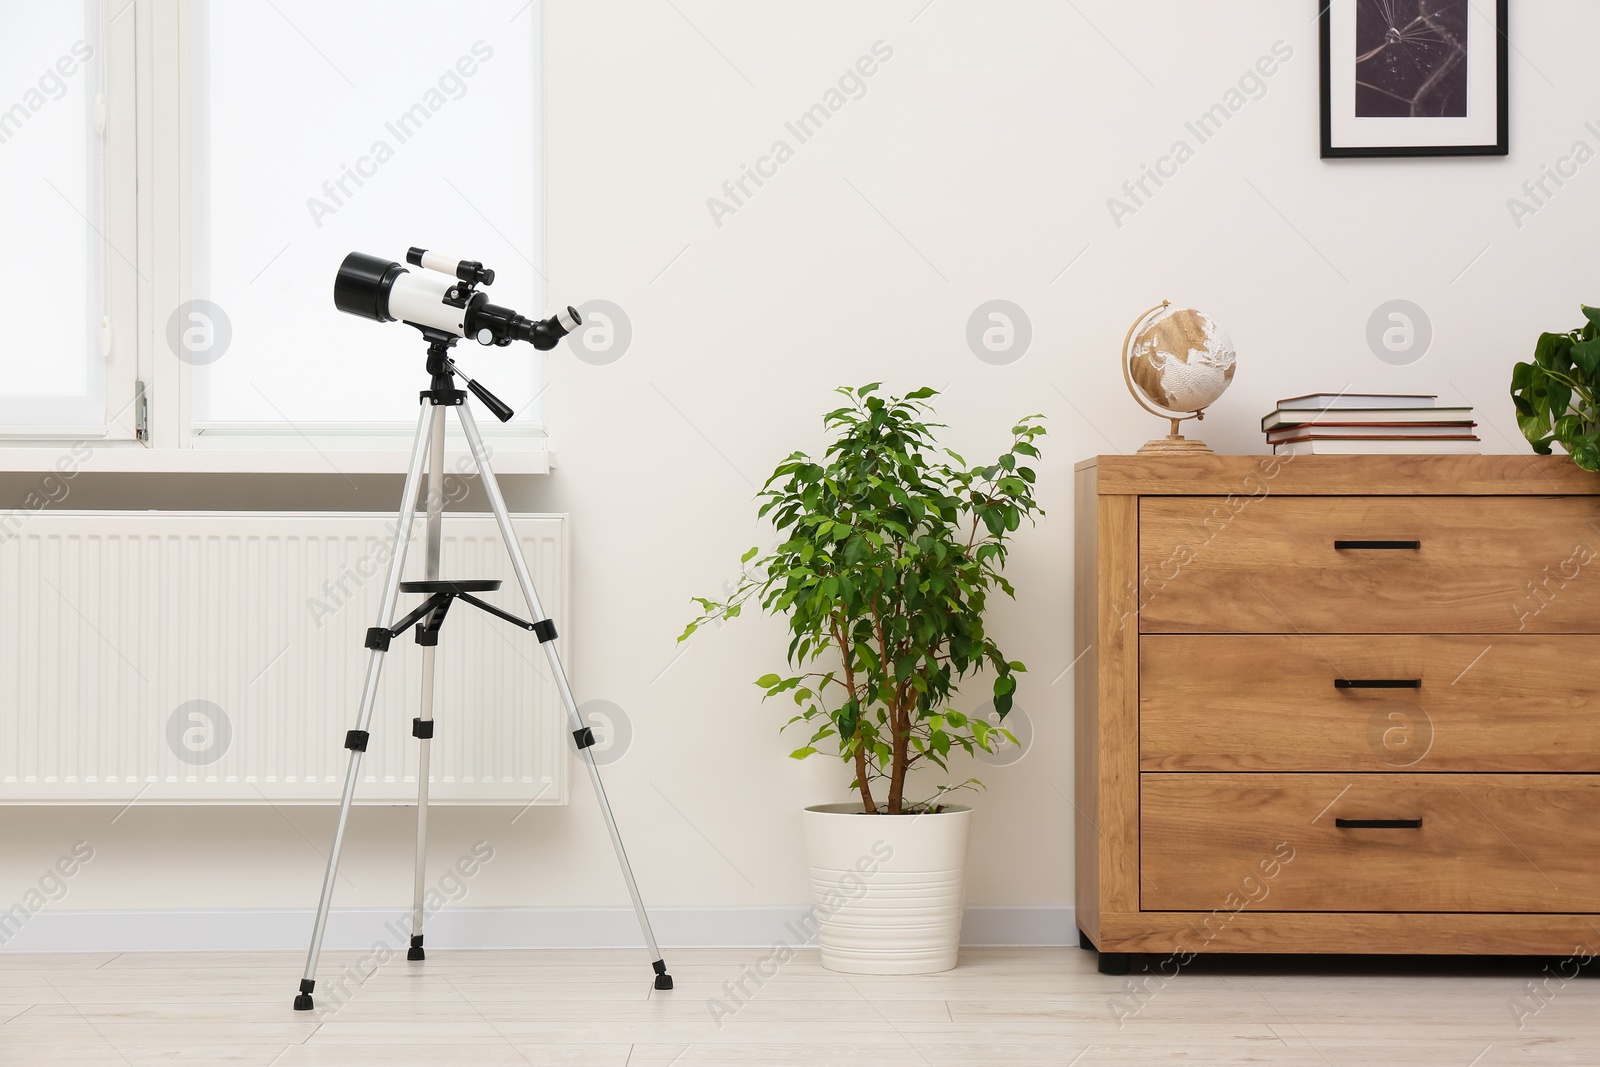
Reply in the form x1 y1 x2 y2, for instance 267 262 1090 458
1122 301 1235 456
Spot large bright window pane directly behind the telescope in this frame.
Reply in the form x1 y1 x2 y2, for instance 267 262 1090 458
184 0 544 434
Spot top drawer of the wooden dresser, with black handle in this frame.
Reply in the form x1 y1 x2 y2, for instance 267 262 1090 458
1138 496 1600 633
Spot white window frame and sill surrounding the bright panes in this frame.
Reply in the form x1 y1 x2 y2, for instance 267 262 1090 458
0 0 550 474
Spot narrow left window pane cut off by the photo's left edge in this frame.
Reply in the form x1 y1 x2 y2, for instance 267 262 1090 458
0 2 133 438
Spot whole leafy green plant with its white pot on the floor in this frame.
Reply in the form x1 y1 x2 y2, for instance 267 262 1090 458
678 384 1045 974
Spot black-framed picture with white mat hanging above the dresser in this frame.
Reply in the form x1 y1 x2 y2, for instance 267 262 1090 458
1318 0 1510 160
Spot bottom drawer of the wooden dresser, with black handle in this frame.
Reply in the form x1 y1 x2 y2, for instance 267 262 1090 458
1139 773 1600 915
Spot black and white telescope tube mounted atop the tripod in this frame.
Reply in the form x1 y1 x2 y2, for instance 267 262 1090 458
333 248 582 352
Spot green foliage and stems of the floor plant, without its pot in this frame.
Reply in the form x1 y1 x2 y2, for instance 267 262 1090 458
678 382 1045 814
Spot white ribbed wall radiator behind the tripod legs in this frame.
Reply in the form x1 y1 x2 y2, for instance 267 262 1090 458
0 512 571 805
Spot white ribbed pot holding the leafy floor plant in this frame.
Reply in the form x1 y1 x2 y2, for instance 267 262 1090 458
805 801 973 974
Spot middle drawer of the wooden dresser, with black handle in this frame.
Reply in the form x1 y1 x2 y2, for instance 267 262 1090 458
1139 639 1600 773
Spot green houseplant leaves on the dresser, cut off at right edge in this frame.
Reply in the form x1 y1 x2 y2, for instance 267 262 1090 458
1510 306 1600 470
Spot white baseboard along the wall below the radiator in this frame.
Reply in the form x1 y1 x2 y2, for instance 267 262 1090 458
0 905 1077 952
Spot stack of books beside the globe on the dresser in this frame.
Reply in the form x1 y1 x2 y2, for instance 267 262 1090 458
1261 392 1478 456
